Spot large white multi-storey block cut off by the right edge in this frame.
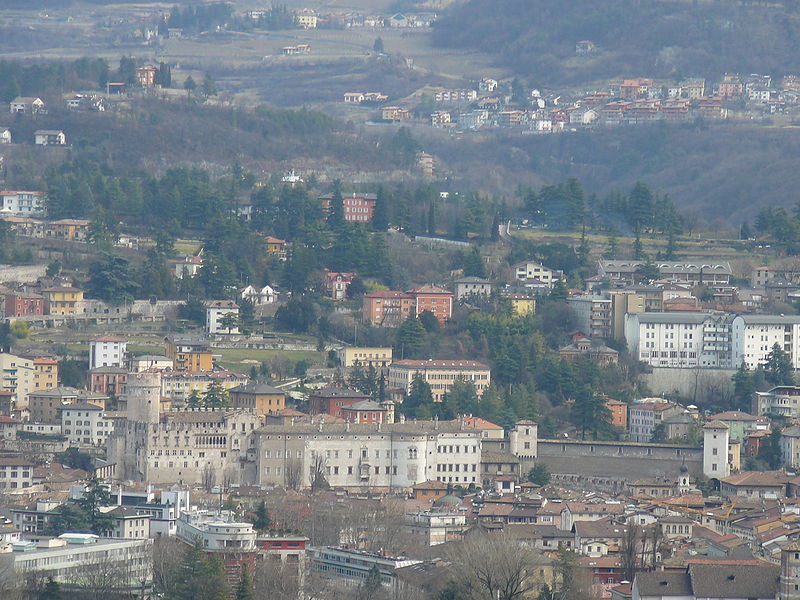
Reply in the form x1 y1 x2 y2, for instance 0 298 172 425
731 315 800 369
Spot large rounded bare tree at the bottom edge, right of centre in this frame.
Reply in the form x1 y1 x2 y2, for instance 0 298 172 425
450 533 544 600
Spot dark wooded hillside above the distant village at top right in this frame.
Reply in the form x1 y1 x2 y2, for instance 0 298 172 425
435 0 800 86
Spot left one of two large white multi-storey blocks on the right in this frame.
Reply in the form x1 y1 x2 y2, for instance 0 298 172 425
625 312 732 369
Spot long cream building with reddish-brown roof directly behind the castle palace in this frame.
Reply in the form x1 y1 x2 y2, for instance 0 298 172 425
387 359 492 402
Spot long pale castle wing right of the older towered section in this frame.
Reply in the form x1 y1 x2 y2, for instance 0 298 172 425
255 421 481 490
